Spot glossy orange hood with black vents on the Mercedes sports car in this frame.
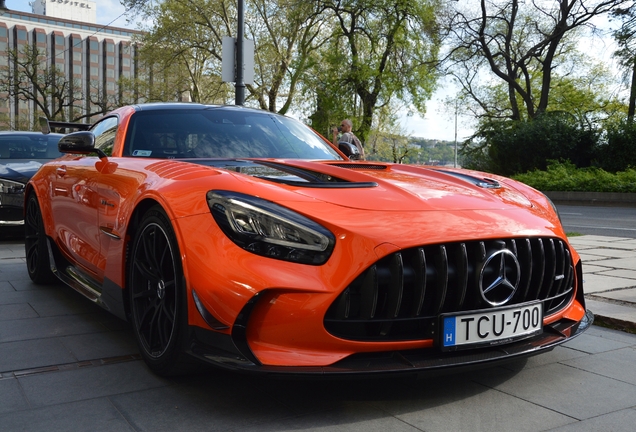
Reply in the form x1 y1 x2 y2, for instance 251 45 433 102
146 159 564 246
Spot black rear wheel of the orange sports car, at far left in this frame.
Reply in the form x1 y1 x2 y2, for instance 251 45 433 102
24 192 57 284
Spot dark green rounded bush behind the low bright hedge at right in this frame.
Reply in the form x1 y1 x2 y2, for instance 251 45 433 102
462 112 599 176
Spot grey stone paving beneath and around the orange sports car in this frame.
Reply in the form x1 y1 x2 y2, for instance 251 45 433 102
0 236 636 432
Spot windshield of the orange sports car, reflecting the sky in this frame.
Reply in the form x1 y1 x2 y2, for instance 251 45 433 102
124 108 342 160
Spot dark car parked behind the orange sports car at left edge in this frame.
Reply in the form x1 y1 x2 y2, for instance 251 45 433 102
0 131 63 227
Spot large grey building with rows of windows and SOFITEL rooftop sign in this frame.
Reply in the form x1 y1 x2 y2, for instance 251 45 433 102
0 4 141 130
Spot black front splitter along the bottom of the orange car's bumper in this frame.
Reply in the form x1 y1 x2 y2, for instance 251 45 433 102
189 310 594 376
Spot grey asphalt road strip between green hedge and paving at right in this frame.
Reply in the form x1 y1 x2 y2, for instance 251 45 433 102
557 205 636 238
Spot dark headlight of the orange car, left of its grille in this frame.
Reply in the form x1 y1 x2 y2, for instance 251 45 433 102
207 191 335 265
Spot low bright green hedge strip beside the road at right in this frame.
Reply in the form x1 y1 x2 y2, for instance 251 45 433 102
512 161 636 193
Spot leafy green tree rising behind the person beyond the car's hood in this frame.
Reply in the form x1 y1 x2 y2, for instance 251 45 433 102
314 0 440 142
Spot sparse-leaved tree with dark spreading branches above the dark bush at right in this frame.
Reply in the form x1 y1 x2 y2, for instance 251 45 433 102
444 0 624 120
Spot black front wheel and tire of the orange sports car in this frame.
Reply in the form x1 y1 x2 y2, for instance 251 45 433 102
128 206 187 376
